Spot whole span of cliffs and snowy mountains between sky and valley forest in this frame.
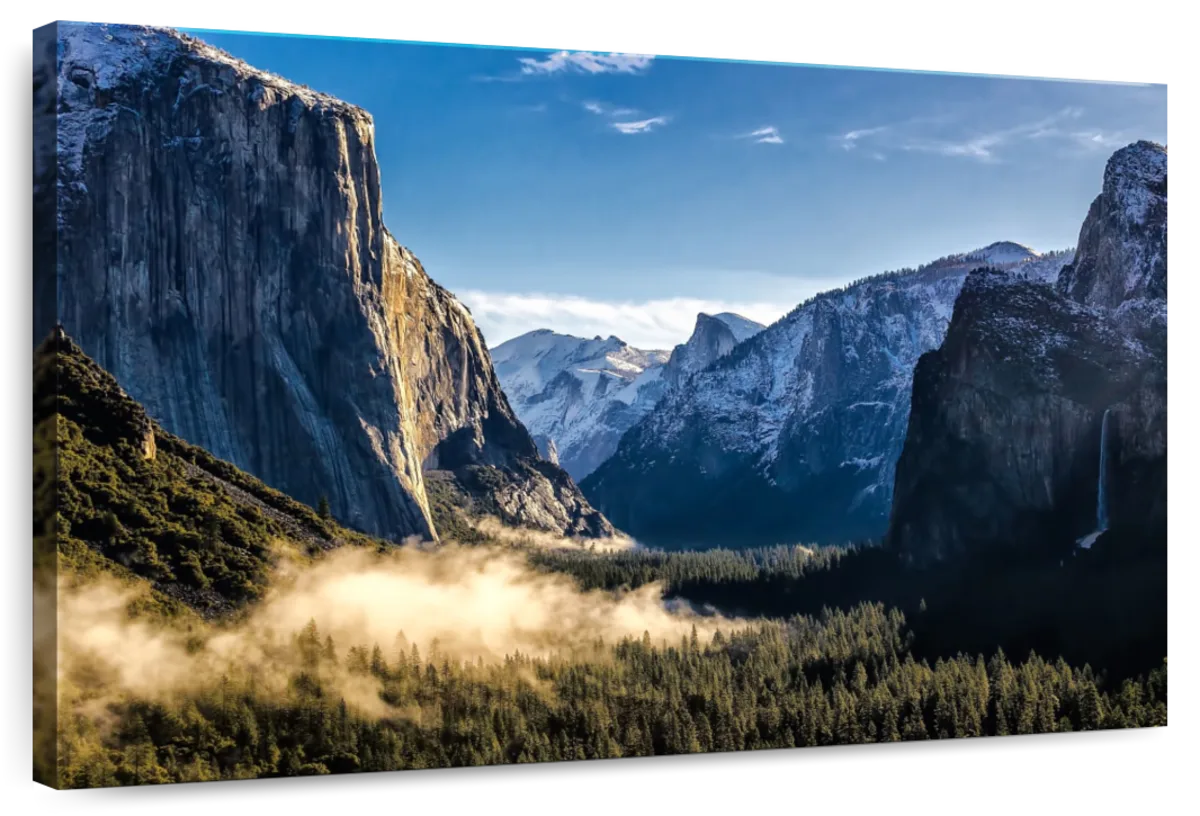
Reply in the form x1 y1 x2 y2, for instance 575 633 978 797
42 24 1168 571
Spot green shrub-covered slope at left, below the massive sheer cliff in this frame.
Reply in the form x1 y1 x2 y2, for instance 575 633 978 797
34 328 384 614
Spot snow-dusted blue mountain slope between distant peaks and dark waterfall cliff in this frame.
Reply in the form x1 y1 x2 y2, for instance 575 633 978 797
581 242 1070 546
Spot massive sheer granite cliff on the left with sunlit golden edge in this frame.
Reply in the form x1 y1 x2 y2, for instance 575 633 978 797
45 24 608 539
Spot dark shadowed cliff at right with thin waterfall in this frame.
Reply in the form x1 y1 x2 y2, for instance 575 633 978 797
888 143 1168 562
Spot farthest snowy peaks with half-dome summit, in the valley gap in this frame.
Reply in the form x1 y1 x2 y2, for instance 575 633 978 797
492 314 763 479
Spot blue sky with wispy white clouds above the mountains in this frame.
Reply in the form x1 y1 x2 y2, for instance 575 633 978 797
182 31 1166 348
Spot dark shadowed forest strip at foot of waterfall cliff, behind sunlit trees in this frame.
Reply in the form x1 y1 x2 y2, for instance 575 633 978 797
530 535 1168 678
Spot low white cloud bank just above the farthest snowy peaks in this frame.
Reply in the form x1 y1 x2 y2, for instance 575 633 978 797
460 292 796 349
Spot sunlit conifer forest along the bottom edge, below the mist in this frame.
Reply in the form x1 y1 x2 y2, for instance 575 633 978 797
59 604 1166 787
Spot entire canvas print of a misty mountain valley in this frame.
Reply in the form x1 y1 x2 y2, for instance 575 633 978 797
32 22 1169 790
